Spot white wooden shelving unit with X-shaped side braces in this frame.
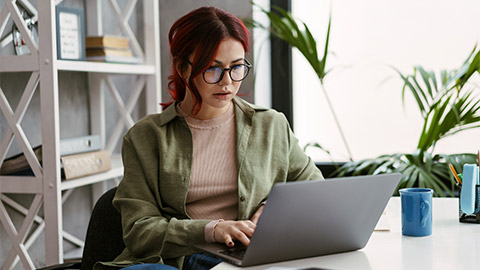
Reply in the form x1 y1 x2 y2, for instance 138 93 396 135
0 0 161 270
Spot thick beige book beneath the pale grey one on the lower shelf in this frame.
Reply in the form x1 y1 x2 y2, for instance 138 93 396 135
60 150 112 180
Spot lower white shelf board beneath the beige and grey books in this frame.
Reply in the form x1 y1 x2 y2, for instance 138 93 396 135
60 155 123 190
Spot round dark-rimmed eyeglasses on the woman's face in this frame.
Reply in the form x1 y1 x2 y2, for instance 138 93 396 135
188 59 252 84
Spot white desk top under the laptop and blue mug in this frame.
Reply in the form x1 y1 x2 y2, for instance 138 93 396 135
213 197 480 270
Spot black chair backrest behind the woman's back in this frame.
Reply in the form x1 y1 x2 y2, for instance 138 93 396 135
81 187 125 270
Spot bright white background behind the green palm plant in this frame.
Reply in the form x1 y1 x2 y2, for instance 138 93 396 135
292 0 480 161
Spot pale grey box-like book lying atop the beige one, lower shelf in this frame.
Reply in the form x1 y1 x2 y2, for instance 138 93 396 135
60 134 102 156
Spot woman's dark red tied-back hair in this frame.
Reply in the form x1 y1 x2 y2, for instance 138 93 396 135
161 7 249 114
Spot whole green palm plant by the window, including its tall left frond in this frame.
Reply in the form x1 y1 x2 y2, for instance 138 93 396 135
253 2 480 196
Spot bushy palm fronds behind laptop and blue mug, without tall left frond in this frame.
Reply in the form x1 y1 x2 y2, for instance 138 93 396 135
337 47 480 196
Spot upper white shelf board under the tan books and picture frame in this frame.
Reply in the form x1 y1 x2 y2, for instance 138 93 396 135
57 60 155 75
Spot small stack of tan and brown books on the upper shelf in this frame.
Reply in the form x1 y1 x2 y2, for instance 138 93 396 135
85 36 140 63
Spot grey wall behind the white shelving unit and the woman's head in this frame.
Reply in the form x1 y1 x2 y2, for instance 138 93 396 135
0 0 254 269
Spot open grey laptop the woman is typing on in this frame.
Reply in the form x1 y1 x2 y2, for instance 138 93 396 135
196 173 401 266
